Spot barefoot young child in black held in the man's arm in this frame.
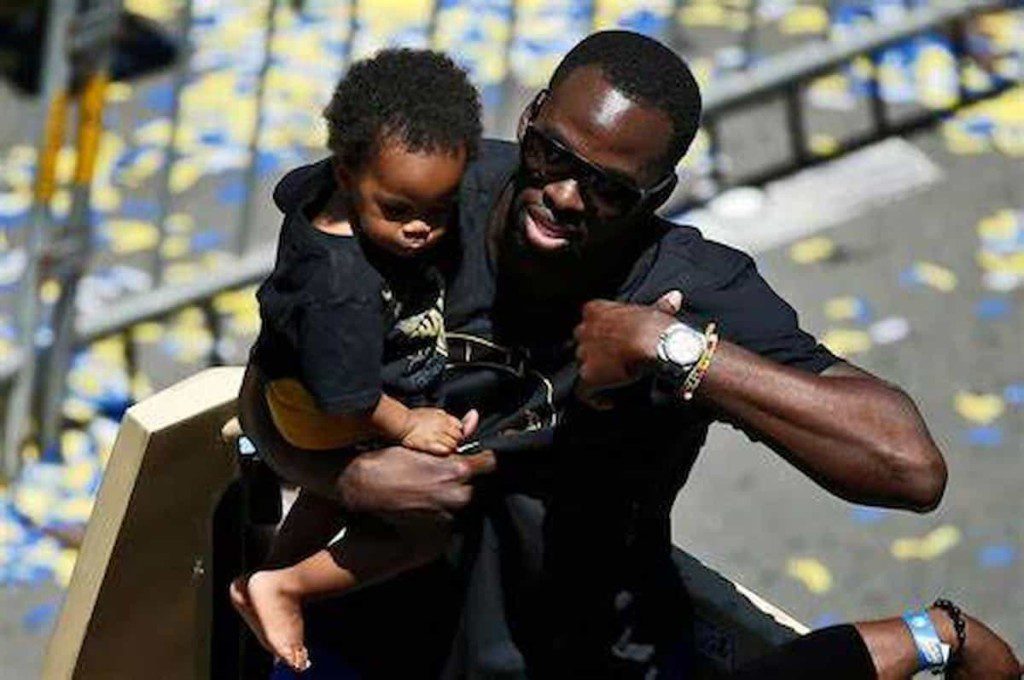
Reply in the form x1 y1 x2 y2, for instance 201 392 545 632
230 49 481 671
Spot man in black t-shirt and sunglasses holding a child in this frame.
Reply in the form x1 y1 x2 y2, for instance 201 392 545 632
237 32 1007 677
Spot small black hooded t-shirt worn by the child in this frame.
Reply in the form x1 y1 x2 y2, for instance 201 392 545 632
251 161 444 414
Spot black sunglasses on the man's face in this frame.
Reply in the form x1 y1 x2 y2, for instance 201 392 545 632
519 96 676 214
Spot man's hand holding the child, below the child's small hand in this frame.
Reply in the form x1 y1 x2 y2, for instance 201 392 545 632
338 411 495 515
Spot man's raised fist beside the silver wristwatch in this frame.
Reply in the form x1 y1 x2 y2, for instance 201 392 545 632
573 291 682 406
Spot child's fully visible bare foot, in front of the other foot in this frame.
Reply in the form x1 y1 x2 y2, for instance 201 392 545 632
248 571 311 673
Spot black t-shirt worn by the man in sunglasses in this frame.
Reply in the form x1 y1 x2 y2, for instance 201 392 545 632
292 140 838 677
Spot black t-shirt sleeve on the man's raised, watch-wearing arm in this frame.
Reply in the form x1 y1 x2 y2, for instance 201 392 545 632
684 251 839 373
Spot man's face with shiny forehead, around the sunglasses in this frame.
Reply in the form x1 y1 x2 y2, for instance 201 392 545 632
512 67 672 254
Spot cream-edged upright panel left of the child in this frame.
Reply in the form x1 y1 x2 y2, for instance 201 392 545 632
43 368 243 680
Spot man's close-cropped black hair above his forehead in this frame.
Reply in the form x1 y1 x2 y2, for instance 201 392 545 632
548 31 700 173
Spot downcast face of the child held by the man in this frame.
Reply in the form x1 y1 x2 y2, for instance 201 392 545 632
339 142 466 257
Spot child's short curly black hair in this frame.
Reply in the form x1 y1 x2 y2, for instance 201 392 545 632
324 48 482 170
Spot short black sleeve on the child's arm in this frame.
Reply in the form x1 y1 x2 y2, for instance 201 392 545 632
297 296 384 414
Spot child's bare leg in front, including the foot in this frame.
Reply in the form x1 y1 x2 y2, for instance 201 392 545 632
246 516 449 670
